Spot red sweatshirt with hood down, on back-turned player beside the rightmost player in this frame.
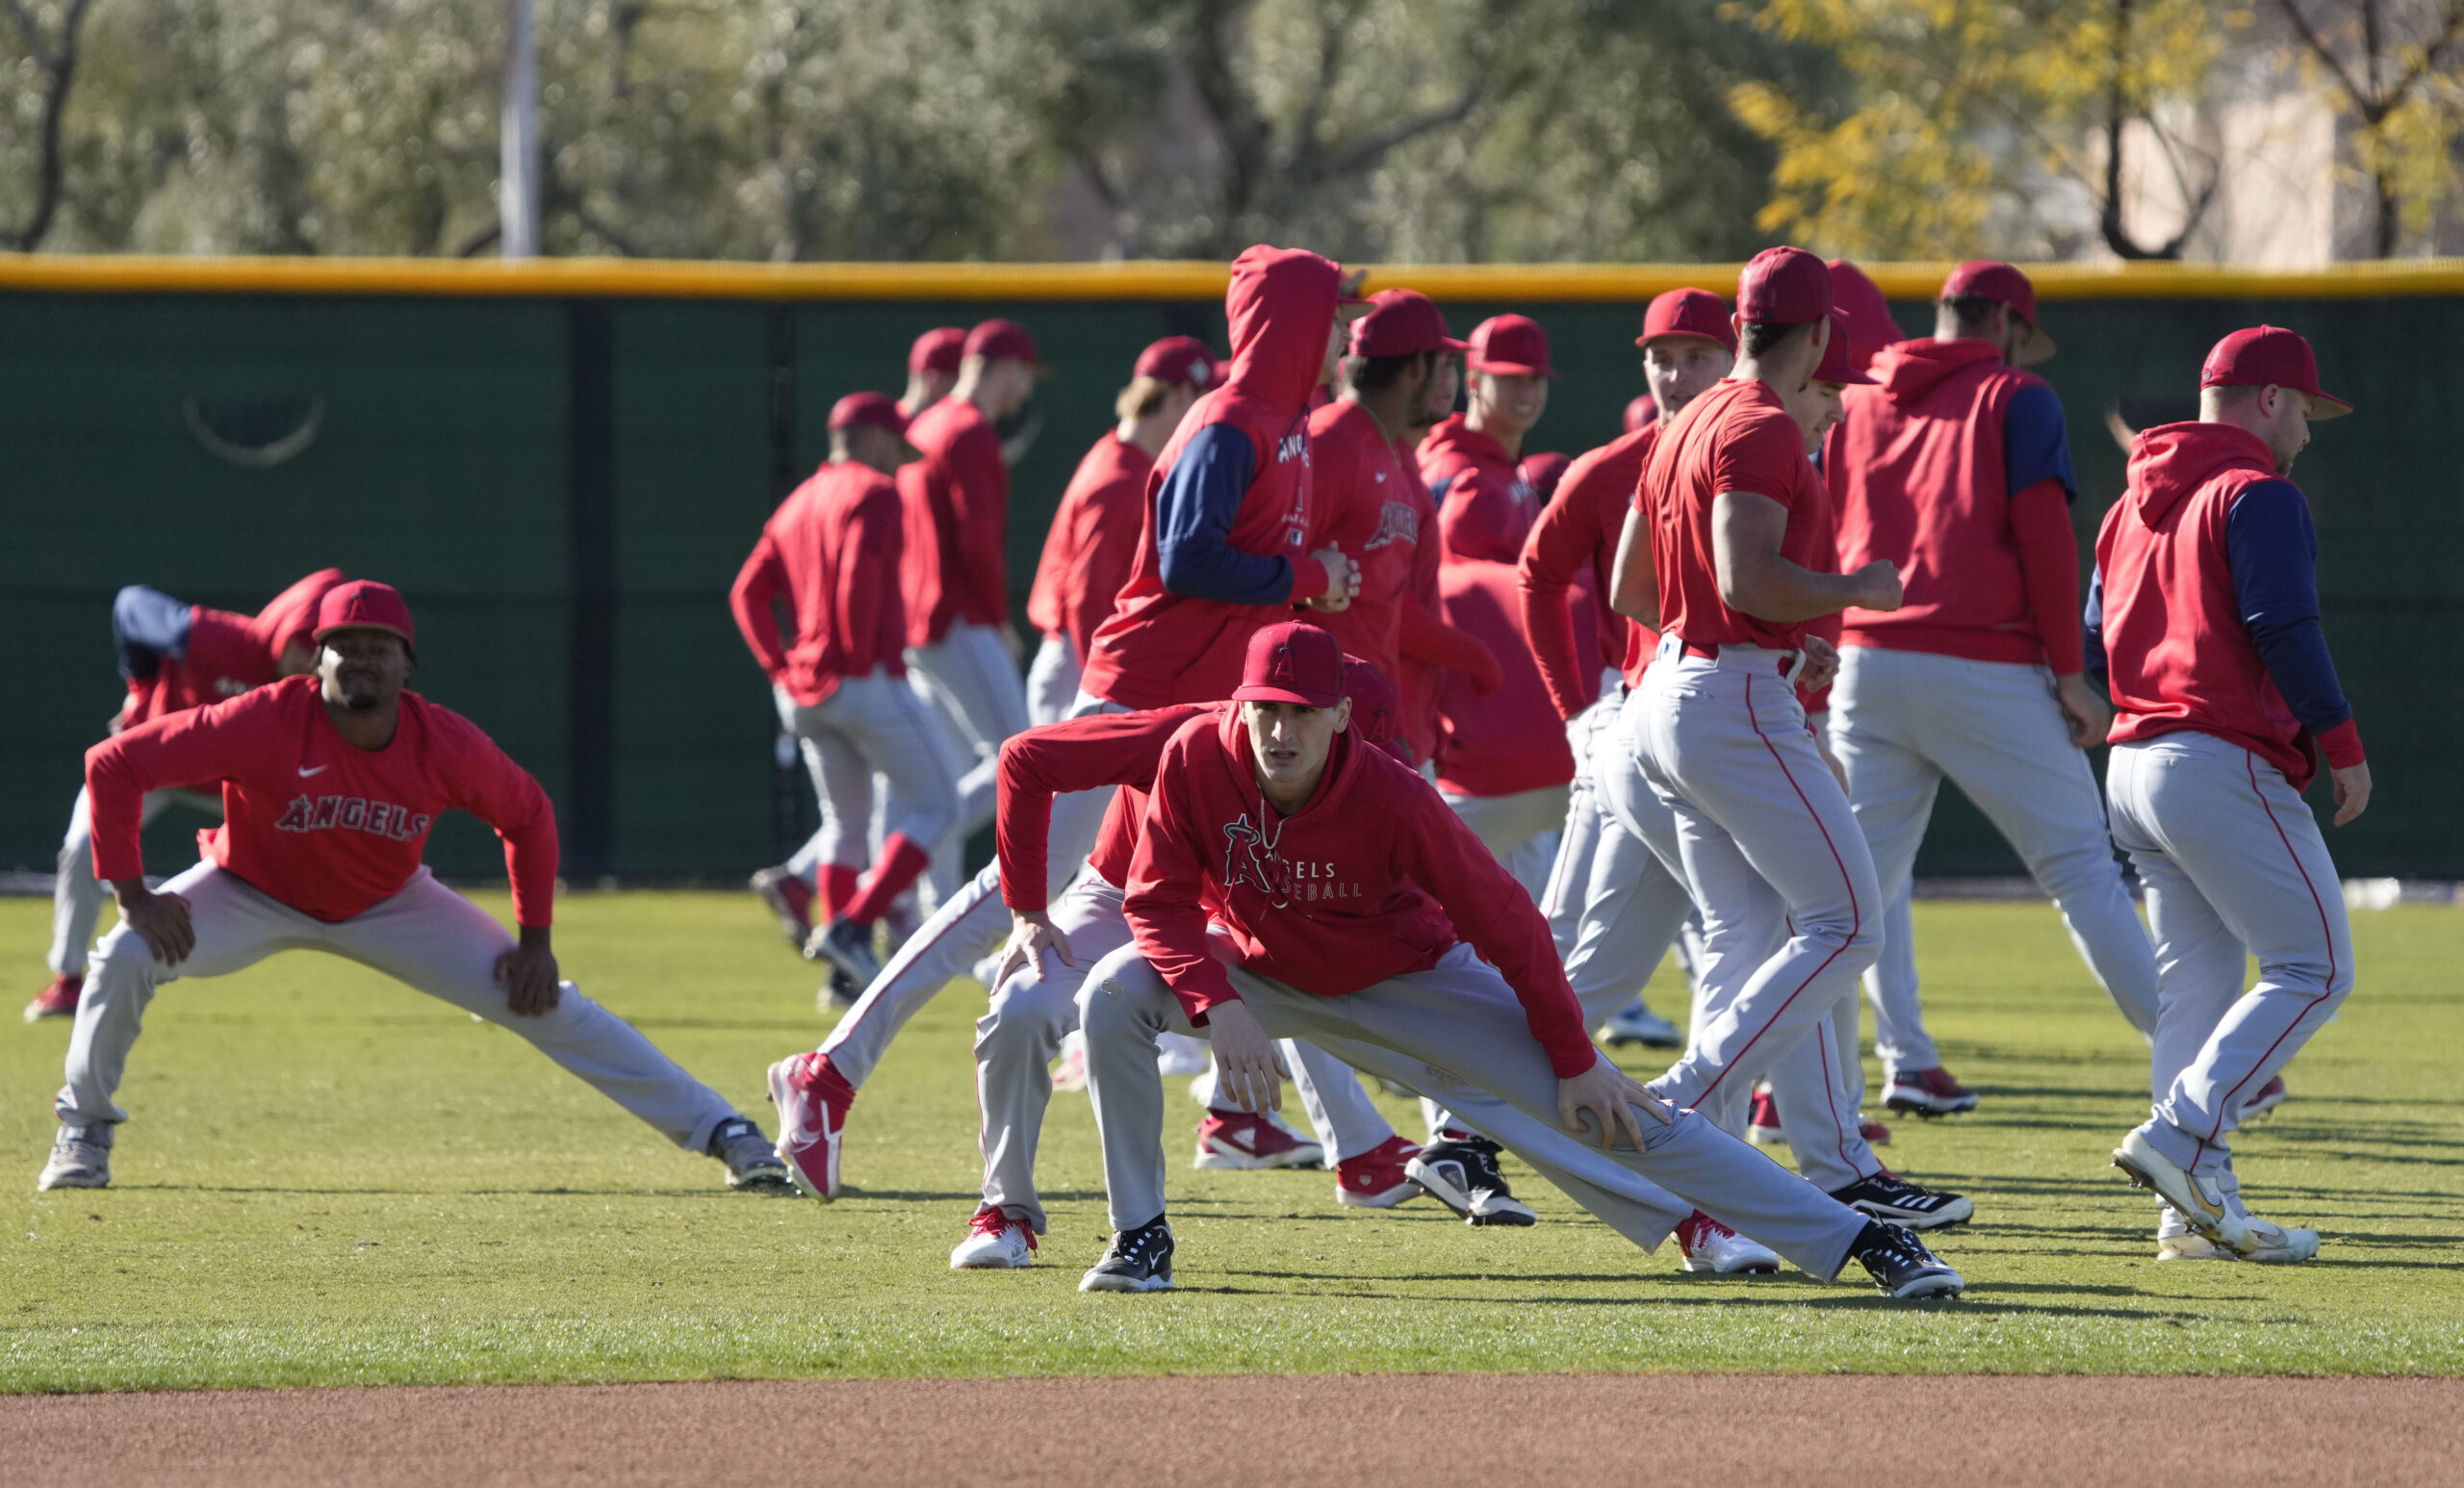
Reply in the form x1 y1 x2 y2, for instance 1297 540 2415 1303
1823 340 2082 675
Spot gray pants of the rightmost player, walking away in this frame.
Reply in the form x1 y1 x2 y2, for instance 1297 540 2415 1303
2104 731 2353 1177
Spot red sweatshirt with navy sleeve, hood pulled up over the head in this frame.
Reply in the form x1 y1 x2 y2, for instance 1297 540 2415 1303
1079 244 1343 707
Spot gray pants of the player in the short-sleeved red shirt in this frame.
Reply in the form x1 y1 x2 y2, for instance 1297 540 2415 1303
1636 635 1883 1188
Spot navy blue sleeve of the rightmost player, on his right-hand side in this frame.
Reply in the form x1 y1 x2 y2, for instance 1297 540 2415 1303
2225 480 2353 734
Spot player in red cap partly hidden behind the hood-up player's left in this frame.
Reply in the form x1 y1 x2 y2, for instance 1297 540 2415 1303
1028 335 1222 725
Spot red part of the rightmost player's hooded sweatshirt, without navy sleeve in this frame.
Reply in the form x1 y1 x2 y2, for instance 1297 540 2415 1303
2097 423 2363 791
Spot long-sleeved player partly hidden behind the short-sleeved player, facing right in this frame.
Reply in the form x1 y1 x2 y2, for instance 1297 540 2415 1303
1515 288 1737 1049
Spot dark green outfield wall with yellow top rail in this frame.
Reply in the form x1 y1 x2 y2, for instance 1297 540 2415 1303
0 259 2464 882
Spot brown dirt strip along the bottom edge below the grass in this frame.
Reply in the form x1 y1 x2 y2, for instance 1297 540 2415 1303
0 1374 2464 1488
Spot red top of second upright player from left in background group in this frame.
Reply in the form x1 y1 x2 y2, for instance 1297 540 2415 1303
899 397 1011 646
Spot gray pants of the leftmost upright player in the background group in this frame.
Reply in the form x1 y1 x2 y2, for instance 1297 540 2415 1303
776 673 956 909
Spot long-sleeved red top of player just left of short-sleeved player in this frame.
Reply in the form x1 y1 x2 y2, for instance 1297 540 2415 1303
1515 423 1660 719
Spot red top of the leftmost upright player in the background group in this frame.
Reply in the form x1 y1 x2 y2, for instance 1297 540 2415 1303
727 461 907 707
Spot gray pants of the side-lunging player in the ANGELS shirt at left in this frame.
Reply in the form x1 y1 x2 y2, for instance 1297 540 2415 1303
52 862 734 1153
